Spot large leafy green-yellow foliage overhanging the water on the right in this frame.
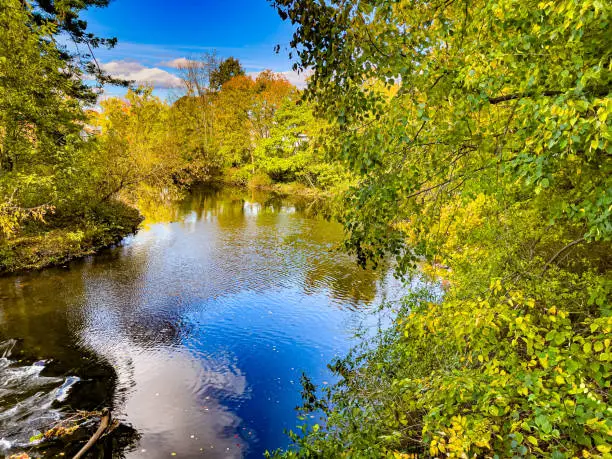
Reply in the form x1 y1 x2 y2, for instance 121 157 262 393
273 0 612 457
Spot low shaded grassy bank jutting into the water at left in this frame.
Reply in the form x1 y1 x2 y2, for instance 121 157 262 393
0 201 143 275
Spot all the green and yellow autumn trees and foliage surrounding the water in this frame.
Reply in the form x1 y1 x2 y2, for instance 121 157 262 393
0 0 612 458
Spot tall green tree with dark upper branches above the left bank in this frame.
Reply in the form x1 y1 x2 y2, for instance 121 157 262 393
0 0 129 238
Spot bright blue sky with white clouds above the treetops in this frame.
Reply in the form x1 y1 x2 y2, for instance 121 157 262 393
84 0 303 97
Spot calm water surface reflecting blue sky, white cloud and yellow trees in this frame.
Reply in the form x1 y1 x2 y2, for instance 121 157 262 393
0 186 406 457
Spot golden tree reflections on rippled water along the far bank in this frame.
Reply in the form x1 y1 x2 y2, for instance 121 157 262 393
136 183 384 306
